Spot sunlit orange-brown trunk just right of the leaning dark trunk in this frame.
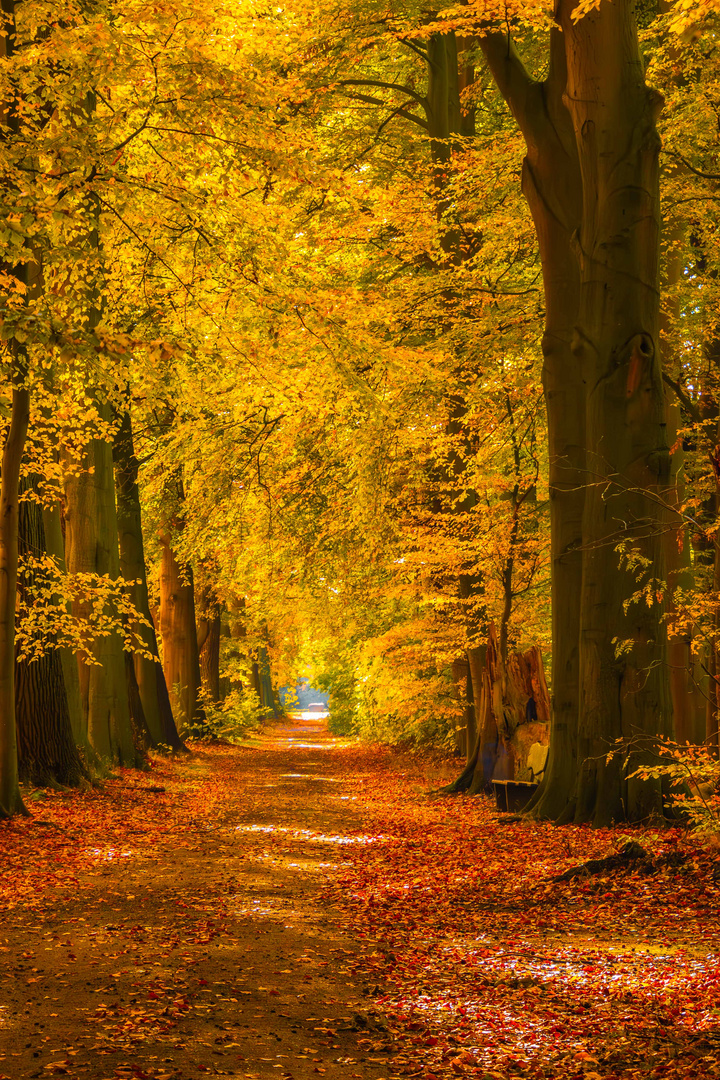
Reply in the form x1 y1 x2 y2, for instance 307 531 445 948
160 532 204 734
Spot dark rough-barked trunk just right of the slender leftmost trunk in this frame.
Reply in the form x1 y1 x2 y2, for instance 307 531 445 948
15 482 86 785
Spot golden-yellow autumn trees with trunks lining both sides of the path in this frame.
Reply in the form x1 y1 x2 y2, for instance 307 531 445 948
0 0 720 824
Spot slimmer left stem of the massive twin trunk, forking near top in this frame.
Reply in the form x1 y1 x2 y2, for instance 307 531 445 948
481 29 586 819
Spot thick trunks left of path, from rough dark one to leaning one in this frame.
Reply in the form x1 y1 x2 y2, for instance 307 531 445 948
8 405 182 784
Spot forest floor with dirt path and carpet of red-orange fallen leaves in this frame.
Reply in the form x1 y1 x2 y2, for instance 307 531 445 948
0 721 720 1080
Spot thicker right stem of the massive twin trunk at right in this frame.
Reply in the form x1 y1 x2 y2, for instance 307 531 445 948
559 0 671 825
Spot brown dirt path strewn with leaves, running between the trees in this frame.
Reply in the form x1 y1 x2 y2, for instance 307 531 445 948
0 723 414 1080
